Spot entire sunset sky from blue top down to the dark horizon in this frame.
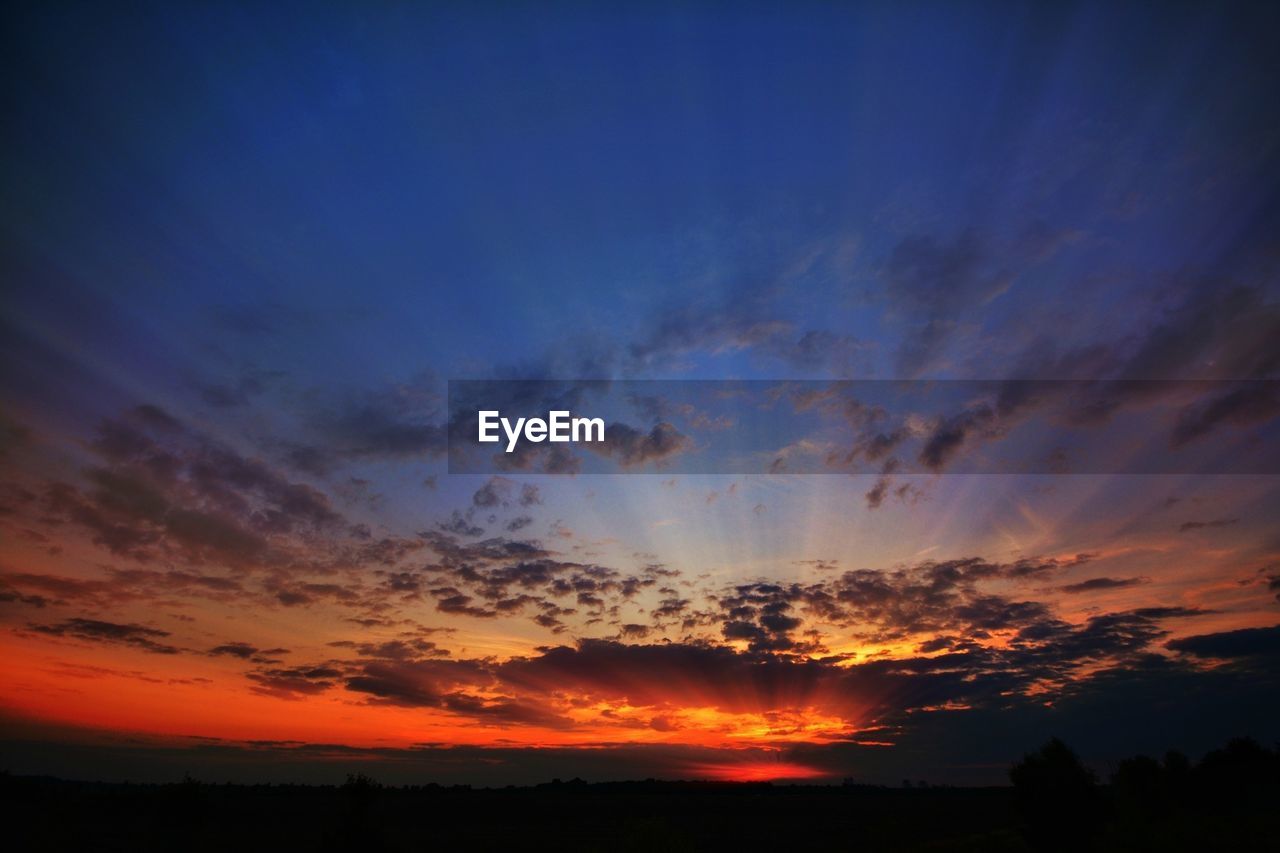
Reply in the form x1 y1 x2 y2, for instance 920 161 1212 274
0 1 1280 785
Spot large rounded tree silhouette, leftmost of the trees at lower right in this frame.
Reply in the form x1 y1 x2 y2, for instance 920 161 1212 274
1009 738 1105 849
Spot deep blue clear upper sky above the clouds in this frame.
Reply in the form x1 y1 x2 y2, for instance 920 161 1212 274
6 4 1274 394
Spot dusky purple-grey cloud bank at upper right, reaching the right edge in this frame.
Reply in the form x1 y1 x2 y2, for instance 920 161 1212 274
757 275 1280 473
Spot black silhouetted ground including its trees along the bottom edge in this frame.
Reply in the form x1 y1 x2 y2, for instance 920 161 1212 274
0 740 1280 853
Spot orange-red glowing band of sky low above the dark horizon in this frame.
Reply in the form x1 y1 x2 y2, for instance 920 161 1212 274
0 479 1270 781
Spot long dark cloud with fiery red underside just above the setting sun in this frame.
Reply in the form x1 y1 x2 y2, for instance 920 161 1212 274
493 596 1198 725
